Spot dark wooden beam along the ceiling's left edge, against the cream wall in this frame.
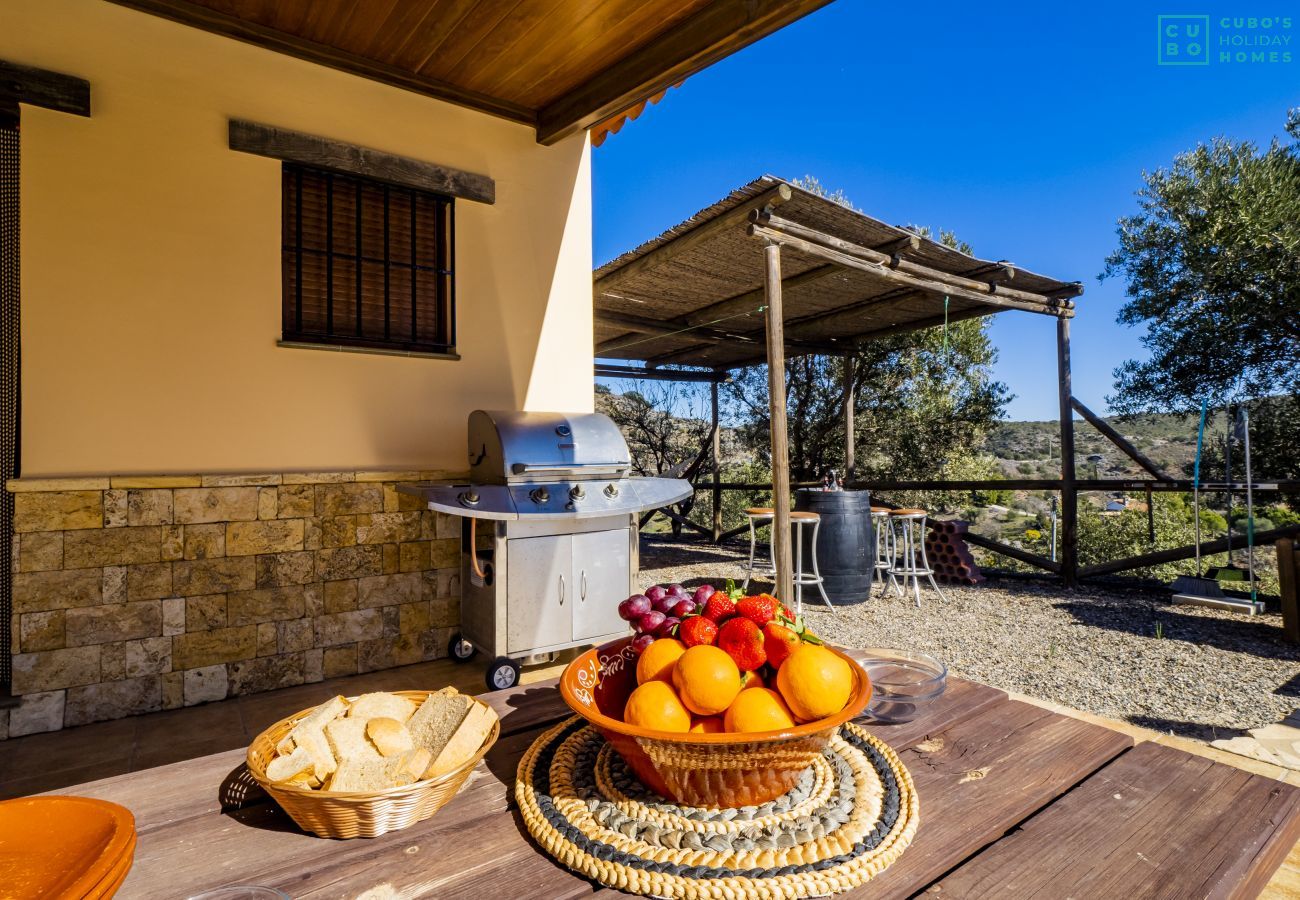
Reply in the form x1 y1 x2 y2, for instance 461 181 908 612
109 0 537 125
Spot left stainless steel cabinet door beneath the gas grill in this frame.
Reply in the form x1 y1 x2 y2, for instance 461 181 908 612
506 535 577 653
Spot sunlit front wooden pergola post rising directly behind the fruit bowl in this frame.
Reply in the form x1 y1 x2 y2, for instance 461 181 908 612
763 242 794 603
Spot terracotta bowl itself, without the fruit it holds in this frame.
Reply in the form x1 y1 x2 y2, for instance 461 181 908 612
560 637 871 808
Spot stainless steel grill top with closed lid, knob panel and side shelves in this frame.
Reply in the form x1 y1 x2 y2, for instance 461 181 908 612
400 410 693 519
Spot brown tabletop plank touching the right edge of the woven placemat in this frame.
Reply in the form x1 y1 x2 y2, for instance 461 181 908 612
845 700 1132 900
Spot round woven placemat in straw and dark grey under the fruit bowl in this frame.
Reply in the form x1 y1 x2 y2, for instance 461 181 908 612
515 717 919 900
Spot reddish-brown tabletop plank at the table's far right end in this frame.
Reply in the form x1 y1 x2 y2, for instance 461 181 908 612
930 743 1300 900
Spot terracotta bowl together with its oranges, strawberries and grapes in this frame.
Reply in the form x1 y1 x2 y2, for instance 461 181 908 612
560 585 871 808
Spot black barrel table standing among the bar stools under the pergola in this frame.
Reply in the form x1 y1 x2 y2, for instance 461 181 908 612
794 488 876 606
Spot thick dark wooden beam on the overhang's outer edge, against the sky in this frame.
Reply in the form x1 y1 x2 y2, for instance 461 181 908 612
537 0 829 144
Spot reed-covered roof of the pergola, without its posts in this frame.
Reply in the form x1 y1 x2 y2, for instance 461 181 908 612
594 176 1083 369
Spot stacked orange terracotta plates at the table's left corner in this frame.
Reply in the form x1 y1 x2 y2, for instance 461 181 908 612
0 797 135 900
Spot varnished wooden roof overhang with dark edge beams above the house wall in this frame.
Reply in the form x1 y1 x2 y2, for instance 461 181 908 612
101 0 829 144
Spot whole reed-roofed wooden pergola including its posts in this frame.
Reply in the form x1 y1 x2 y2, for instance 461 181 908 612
594 176 1081 597
